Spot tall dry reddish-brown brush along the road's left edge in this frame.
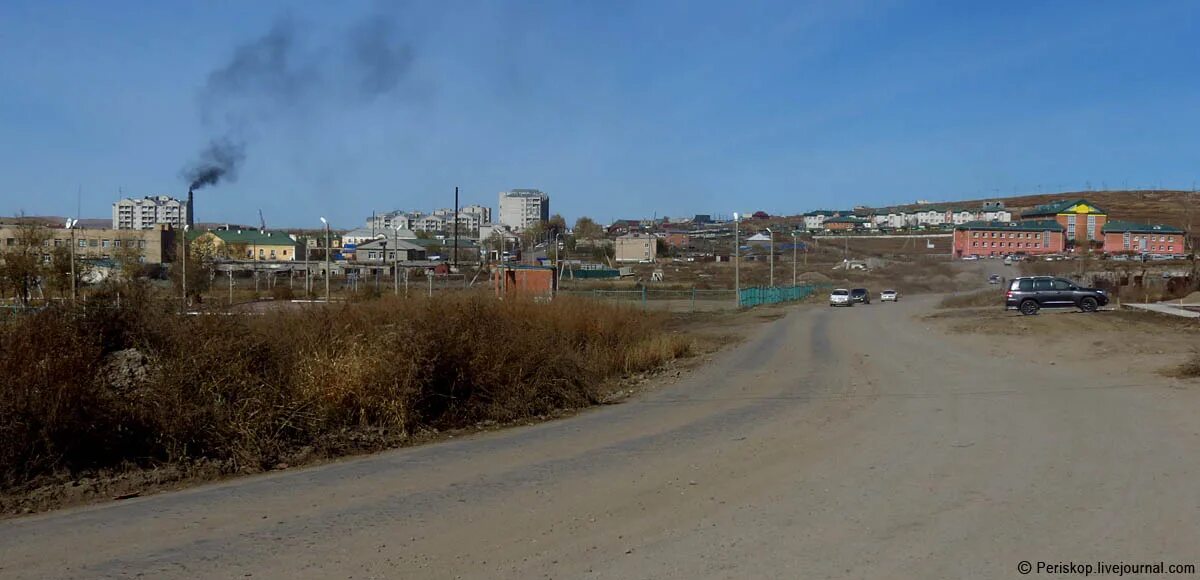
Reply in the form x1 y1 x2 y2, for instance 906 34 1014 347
0 283 692 492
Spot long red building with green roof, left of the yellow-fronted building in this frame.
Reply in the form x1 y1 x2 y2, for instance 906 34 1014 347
954 220 1066 258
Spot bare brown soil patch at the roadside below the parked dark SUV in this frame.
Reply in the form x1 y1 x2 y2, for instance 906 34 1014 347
922 307 1200 376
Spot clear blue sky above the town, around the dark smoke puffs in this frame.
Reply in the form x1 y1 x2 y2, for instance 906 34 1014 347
0 0 1200 227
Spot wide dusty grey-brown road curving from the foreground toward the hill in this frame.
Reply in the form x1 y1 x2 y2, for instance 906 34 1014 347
0 293 1200 579
